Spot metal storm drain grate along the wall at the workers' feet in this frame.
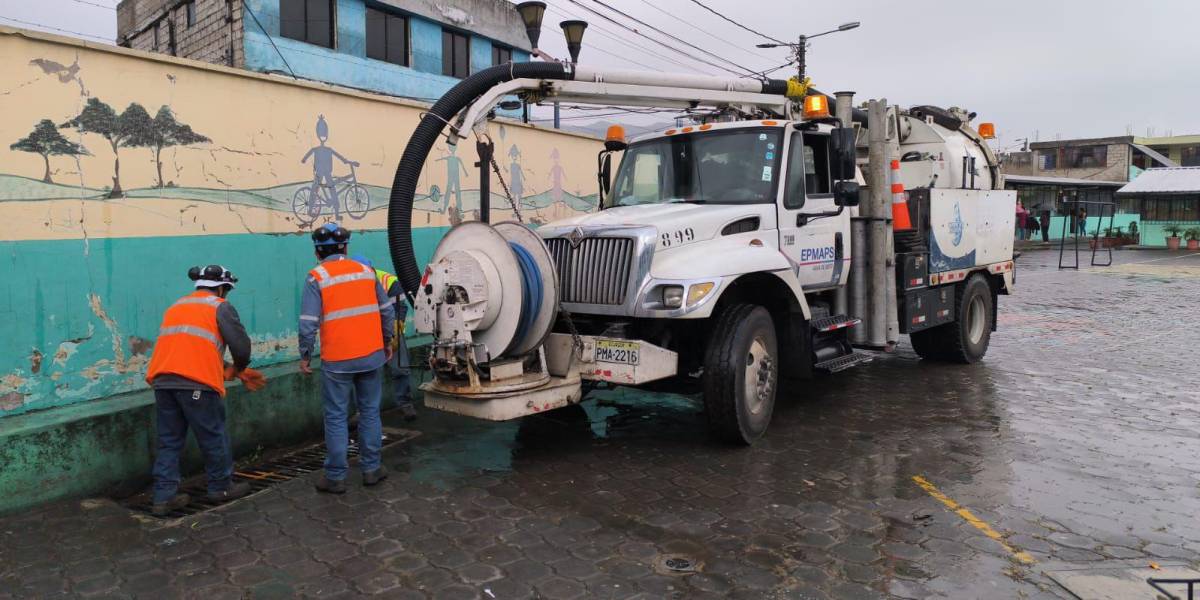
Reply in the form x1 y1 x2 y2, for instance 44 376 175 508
121 427 419 520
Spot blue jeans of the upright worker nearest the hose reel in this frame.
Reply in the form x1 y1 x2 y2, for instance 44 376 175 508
320 368 383 481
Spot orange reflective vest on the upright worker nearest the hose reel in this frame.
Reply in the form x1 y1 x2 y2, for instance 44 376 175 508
308 258 388 360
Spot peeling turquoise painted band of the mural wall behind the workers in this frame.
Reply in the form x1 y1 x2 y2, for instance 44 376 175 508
0 227 446 416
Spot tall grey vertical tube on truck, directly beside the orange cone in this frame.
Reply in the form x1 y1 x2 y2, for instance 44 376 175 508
866 98 892 348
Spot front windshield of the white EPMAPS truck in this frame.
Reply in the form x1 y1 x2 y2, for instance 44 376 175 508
605 127 782 208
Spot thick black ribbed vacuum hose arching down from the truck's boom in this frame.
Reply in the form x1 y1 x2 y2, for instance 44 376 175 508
388 62 575 301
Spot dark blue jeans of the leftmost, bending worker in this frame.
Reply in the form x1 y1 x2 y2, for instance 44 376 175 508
154 390 233 503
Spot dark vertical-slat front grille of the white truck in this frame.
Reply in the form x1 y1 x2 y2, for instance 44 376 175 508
546 238 634 305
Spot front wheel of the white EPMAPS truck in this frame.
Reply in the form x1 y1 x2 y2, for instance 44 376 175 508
702 304 779 445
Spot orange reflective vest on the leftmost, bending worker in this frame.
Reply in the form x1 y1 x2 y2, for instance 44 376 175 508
146 292 224 396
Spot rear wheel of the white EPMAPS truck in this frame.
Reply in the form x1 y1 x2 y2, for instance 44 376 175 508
908 274 996 365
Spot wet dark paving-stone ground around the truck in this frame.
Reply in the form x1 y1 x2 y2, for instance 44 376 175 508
0 251 1200 600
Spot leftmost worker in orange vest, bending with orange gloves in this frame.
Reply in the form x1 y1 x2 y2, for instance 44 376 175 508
146 265 266 516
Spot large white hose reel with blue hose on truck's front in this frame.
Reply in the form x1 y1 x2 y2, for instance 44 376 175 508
415 222 559 365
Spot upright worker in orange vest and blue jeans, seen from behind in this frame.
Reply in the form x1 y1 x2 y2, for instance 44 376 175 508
299 223 395 493
